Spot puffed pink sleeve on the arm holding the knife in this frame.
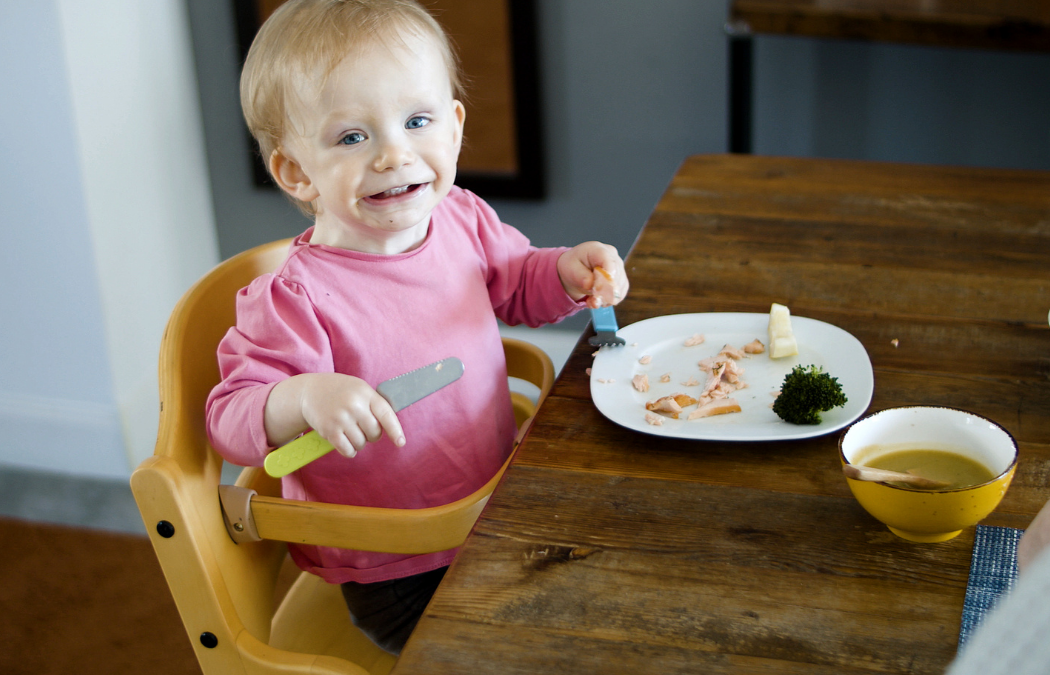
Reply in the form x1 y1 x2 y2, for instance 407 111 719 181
206 274 334 466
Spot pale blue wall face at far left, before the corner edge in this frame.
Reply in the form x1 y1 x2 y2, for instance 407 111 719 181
0 2 127 474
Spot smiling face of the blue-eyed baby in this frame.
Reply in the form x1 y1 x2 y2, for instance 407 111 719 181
277 30 465 254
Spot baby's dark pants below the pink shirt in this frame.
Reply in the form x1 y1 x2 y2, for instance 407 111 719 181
341 567 448 654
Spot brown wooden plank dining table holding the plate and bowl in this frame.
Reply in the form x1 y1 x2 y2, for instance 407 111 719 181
394 155 1050 675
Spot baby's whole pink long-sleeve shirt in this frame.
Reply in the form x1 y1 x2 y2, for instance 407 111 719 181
207 188 584 583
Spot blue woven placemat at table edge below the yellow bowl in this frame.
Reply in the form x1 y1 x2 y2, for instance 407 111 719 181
959 525 1025 647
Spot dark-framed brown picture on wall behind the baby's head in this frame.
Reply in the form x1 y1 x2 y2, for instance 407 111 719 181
233 0 546 199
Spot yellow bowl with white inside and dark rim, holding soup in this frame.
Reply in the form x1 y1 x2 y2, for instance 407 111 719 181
839 406 1017 543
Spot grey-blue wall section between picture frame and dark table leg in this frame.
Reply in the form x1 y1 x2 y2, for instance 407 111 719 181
485 0 728 261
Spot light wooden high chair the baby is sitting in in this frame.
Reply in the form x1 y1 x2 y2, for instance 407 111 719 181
131 239 554 675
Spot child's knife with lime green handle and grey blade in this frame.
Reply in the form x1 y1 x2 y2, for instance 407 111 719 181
263 356 463 478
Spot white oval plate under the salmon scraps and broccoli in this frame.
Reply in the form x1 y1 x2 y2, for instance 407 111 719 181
590 313 875 441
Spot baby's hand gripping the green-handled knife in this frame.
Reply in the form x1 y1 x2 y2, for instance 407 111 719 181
266 373 405 457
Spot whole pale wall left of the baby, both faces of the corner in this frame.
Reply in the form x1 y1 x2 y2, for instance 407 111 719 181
0 0 218 478
